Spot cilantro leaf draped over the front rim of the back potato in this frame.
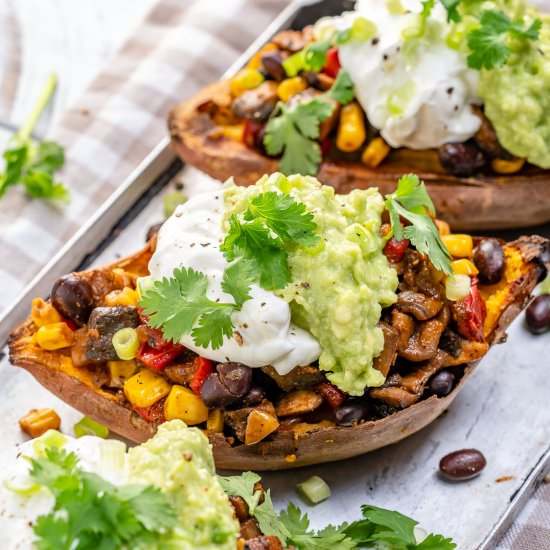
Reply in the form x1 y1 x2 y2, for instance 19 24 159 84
264 69 355 175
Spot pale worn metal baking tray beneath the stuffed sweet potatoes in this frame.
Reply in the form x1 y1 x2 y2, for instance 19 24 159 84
0 0 550 550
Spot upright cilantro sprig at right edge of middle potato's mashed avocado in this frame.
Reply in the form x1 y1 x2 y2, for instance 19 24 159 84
386 174 452 275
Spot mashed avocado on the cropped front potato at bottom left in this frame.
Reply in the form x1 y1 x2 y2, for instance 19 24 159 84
127 420 239 550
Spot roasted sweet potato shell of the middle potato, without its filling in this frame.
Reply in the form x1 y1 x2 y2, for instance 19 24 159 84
9 236 550 470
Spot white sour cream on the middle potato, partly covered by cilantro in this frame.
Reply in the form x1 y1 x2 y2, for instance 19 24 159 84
149 191 321 374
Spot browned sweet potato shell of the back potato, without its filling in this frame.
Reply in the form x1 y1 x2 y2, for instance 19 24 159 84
168 80 550 231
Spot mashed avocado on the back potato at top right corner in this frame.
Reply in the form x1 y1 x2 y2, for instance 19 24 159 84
460 0 550 168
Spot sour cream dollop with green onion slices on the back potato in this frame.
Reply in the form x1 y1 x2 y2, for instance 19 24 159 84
316 0 480 149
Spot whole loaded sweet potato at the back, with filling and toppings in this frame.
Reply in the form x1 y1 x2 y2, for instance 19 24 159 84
168 0 550 230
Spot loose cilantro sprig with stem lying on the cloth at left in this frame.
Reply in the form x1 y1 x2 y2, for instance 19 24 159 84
0 75 69 202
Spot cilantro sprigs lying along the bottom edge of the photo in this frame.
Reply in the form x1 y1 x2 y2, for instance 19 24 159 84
219 472 456 550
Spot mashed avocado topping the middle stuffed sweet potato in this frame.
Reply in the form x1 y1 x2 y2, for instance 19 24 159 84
225 174 398 395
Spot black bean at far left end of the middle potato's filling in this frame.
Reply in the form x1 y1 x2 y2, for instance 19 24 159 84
52 273 94 327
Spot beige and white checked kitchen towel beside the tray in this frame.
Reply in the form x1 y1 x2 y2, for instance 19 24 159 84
0 0 289 315
